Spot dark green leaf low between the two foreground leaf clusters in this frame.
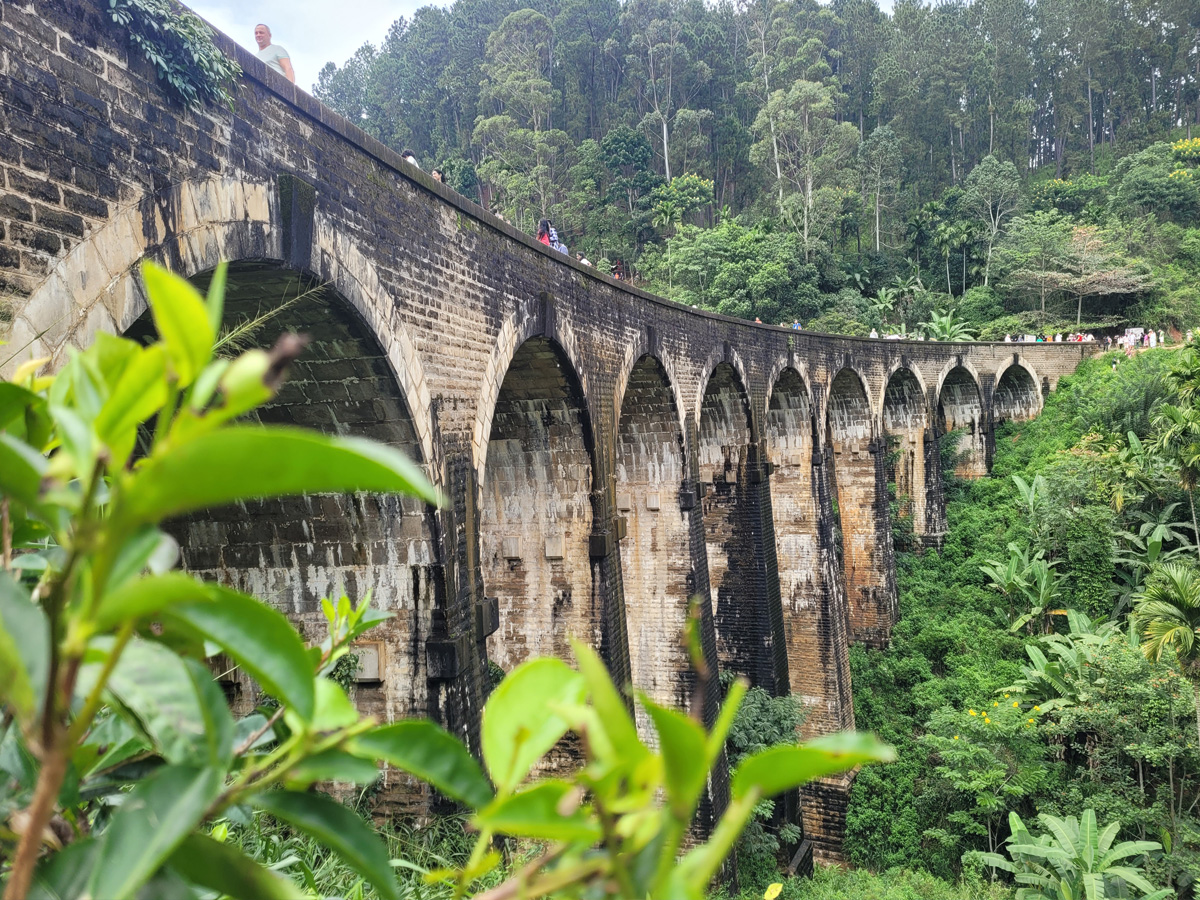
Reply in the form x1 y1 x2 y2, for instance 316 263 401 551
350 719 492 809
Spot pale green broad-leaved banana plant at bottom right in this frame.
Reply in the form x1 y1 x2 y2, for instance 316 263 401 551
983 809 1174 900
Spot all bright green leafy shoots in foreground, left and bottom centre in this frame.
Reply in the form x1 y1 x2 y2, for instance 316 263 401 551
0 271 892 900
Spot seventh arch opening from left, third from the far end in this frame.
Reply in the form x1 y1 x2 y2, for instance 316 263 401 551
883 368 929 550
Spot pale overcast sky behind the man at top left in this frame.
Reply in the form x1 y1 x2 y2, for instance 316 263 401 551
185 0 892 90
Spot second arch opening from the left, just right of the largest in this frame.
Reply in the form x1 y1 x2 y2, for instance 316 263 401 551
480 337 602 671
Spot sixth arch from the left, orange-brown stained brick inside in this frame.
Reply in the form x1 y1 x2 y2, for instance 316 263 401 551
826 368 896 647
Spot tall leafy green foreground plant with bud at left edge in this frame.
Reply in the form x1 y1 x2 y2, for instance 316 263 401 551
0 265 441 898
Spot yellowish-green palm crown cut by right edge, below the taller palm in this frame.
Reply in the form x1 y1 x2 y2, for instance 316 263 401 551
1134 563 1200 737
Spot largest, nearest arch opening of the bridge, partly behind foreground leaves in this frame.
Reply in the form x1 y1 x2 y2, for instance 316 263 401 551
126 260 438 768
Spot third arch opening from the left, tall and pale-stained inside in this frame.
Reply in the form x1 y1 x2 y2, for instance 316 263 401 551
616 355 694 734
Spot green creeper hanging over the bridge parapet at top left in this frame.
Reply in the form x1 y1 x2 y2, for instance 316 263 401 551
108 0 241 109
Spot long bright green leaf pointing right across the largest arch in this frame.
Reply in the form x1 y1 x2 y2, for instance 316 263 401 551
114 425 438 528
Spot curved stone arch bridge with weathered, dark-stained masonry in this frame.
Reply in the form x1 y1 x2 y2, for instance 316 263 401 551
0 0 1087 850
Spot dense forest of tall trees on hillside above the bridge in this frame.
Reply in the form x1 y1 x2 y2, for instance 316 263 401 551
314 0 1200 337
